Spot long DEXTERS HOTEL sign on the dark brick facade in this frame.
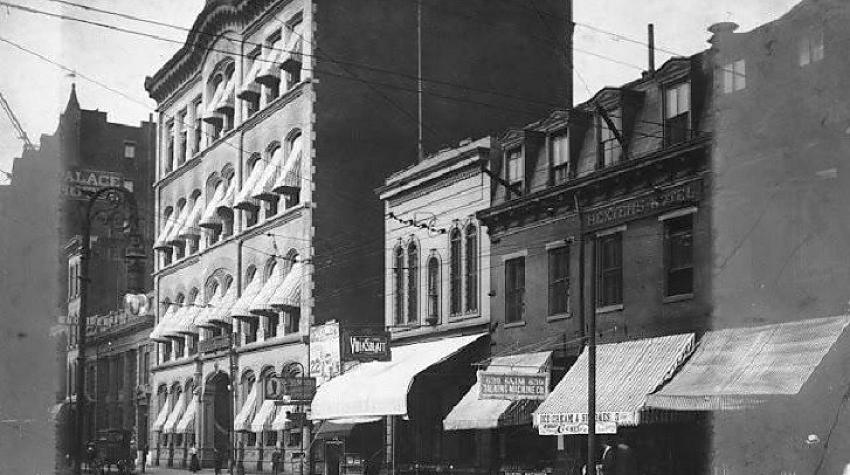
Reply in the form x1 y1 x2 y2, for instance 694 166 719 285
583 180 702 230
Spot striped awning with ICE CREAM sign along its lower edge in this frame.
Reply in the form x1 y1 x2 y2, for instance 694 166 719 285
534 333 695 434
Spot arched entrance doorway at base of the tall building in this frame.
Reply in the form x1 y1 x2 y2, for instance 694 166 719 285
204 372 233 462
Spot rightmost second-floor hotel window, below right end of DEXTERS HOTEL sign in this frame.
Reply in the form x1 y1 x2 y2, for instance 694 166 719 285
664 214 694 297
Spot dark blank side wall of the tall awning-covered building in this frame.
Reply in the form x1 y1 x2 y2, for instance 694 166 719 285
313 0 568 322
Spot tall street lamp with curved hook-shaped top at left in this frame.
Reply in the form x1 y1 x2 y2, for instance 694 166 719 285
74 186 145 475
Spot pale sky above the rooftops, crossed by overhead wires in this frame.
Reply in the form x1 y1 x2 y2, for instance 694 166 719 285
0 0 798 182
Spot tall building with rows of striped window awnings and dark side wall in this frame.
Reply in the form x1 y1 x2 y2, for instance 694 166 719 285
146 0 568 474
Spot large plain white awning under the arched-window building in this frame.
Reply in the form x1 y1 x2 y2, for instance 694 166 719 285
310 334 484 420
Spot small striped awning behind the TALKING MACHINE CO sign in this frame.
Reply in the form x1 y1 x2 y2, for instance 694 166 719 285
443 351 552 430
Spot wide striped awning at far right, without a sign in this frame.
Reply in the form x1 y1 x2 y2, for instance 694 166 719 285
648 316 850 411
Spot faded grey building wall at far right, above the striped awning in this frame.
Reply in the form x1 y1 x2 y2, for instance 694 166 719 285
711 1 850 327
